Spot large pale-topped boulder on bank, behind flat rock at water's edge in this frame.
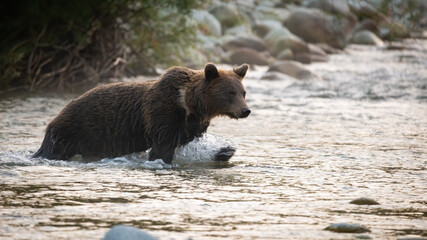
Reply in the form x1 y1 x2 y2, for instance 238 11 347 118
264 27 309 56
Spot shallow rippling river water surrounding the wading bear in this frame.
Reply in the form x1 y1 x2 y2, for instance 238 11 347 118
0 40 427 239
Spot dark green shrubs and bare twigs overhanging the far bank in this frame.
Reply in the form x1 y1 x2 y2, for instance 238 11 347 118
0 0 198 90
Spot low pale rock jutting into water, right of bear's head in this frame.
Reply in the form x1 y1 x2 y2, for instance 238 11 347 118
268 61 320 80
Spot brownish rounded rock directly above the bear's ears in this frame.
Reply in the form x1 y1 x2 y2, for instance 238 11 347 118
229 48 268 66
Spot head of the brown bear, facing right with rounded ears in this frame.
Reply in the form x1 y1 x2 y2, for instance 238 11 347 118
204 63 251 119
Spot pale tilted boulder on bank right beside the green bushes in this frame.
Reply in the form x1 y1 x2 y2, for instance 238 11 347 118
191 9 222 37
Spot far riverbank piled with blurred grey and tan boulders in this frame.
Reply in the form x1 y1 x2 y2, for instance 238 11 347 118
184 0 427 80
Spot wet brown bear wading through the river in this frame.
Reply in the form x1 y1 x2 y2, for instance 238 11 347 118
33 63 251 164
